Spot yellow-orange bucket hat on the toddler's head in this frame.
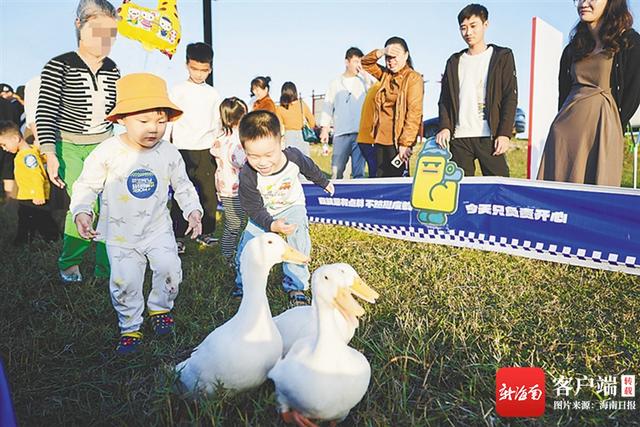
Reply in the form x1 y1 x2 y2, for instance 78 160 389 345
107 73 182 122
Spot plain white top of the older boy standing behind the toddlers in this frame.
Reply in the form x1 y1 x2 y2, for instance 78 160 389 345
165 80 222 150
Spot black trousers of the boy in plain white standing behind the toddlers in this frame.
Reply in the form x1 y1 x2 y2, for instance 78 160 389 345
171 150 218 237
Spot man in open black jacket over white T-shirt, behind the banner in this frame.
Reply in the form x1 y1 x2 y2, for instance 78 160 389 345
436 4 518 176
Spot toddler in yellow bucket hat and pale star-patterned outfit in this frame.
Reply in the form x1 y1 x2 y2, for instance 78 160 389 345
70 73 202 354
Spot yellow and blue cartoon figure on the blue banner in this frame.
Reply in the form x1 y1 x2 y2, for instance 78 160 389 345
411 137 464 226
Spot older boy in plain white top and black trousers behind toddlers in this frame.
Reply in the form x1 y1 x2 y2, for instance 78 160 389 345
165 43 222 253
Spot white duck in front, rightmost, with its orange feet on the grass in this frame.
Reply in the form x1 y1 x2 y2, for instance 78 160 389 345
269 265 378 427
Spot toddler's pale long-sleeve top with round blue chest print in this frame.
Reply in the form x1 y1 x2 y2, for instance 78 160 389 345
69 136 203 248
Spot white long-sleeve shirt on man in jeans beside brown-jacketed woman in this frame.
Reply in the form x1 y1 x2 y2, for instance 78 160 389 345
320 74 371 136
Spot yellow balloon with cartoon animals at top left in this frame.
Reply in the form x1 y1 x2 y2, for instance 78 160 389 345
118 0 180 59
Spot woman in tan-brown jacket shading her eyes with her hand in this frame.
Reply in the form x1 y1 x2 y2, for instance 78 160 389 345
362 37 424 177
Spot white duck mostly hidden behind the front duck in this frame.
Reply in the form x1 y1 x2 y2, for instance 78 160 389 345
273 263 378 355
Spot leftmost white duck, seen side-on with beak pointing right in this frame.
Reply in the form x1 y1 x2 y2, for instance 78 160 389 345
176 233 309 394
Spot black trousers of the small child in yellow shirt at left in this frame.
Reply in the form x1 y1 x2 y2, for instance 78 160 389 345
14 200 60 244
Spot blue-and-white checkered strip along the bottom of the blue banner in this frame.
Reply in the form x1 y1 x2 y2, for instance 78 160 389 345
309 216 640 275
